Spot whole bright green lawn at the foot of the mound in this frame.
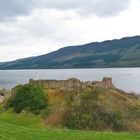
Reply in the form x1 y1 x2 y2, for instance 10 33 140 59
0 110 140 140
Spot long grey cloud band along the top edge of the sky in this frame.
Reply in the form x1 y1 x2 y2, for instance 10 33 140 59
0 0 131 21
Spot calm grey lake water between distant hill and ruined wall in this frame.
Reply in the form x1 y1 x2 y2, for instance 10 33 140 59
0 68 140 93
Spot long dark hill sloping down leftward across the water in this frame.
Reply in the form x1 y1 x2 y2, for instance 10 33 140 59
0 36 140 69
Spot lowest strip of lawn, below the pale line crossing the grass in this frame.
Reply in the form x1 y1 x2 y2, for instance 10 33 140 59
0 121 140 140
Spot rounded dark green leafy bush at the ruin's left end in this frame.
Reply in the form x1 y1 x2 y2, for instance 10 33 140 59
10 84 48 114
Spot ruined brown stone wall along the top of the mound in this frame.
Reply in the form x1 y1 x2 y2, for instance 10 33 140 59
29 77 113 91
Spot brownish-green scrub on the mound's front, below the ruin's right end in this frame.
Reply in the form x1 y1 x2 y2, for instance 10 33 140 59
63 88 126 131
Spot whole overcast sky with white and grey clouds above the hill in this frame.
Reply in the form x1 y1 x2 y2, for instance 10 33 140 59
0 0 140 62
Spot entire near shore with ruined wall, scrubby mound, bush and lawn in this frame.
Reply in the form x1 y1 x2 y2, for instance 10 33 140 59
0 77 140 140
